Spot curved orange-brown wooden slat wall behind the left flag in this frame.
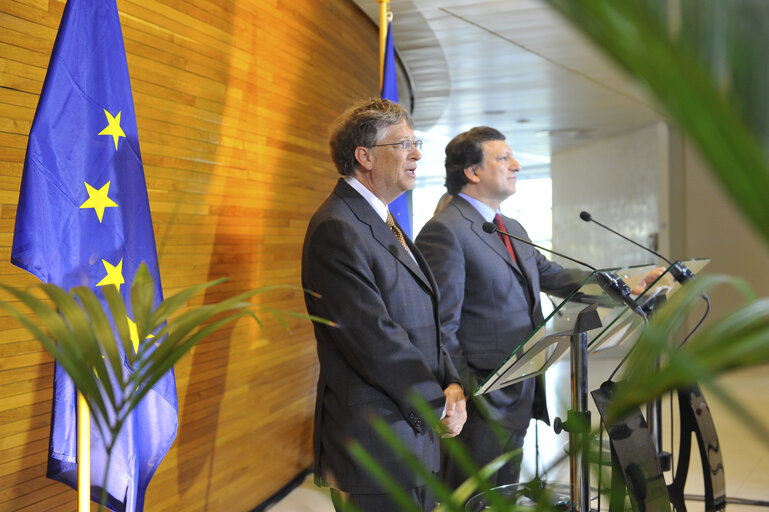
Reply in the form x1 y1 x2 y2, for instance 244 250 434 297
0 0 378 511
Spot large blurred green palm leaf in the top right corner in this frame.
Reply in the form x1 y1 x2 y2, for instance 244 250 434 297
545 0 769 246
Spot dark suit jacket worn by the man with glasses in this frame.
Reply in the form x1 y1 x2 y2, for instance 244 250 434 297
302 180 460 493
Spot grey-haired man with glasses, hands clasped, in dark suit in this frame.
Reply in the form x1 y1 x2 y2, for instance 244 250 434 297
302 99 466 512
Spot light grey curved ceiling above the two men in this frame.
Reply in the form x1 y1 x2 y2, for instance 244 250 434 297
354 0 662 178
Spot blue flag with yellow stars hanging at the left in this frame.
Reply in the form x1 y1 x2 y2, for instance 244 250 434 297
11 0 178 511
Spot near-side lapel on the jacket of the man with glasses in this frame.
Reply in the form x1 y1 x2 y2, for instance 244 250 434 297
334 179 435 294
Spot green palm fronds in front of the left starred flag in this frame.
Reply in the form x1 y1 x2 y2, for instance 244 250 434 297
0 265 333 510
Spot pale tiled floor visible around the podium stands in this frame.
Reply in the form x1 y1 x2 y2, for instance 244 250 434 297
270 355 769 512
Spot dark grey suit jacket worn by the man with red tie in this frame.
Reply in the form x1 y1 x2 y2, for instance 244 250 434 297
416 197 585 428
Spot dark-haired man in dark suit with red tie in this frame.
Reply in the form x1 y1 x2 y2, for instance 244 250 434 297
416 127 586 486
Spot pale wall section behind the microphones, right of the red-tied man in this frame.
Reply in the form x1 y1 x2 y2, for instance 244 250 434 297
550 125 661 267
